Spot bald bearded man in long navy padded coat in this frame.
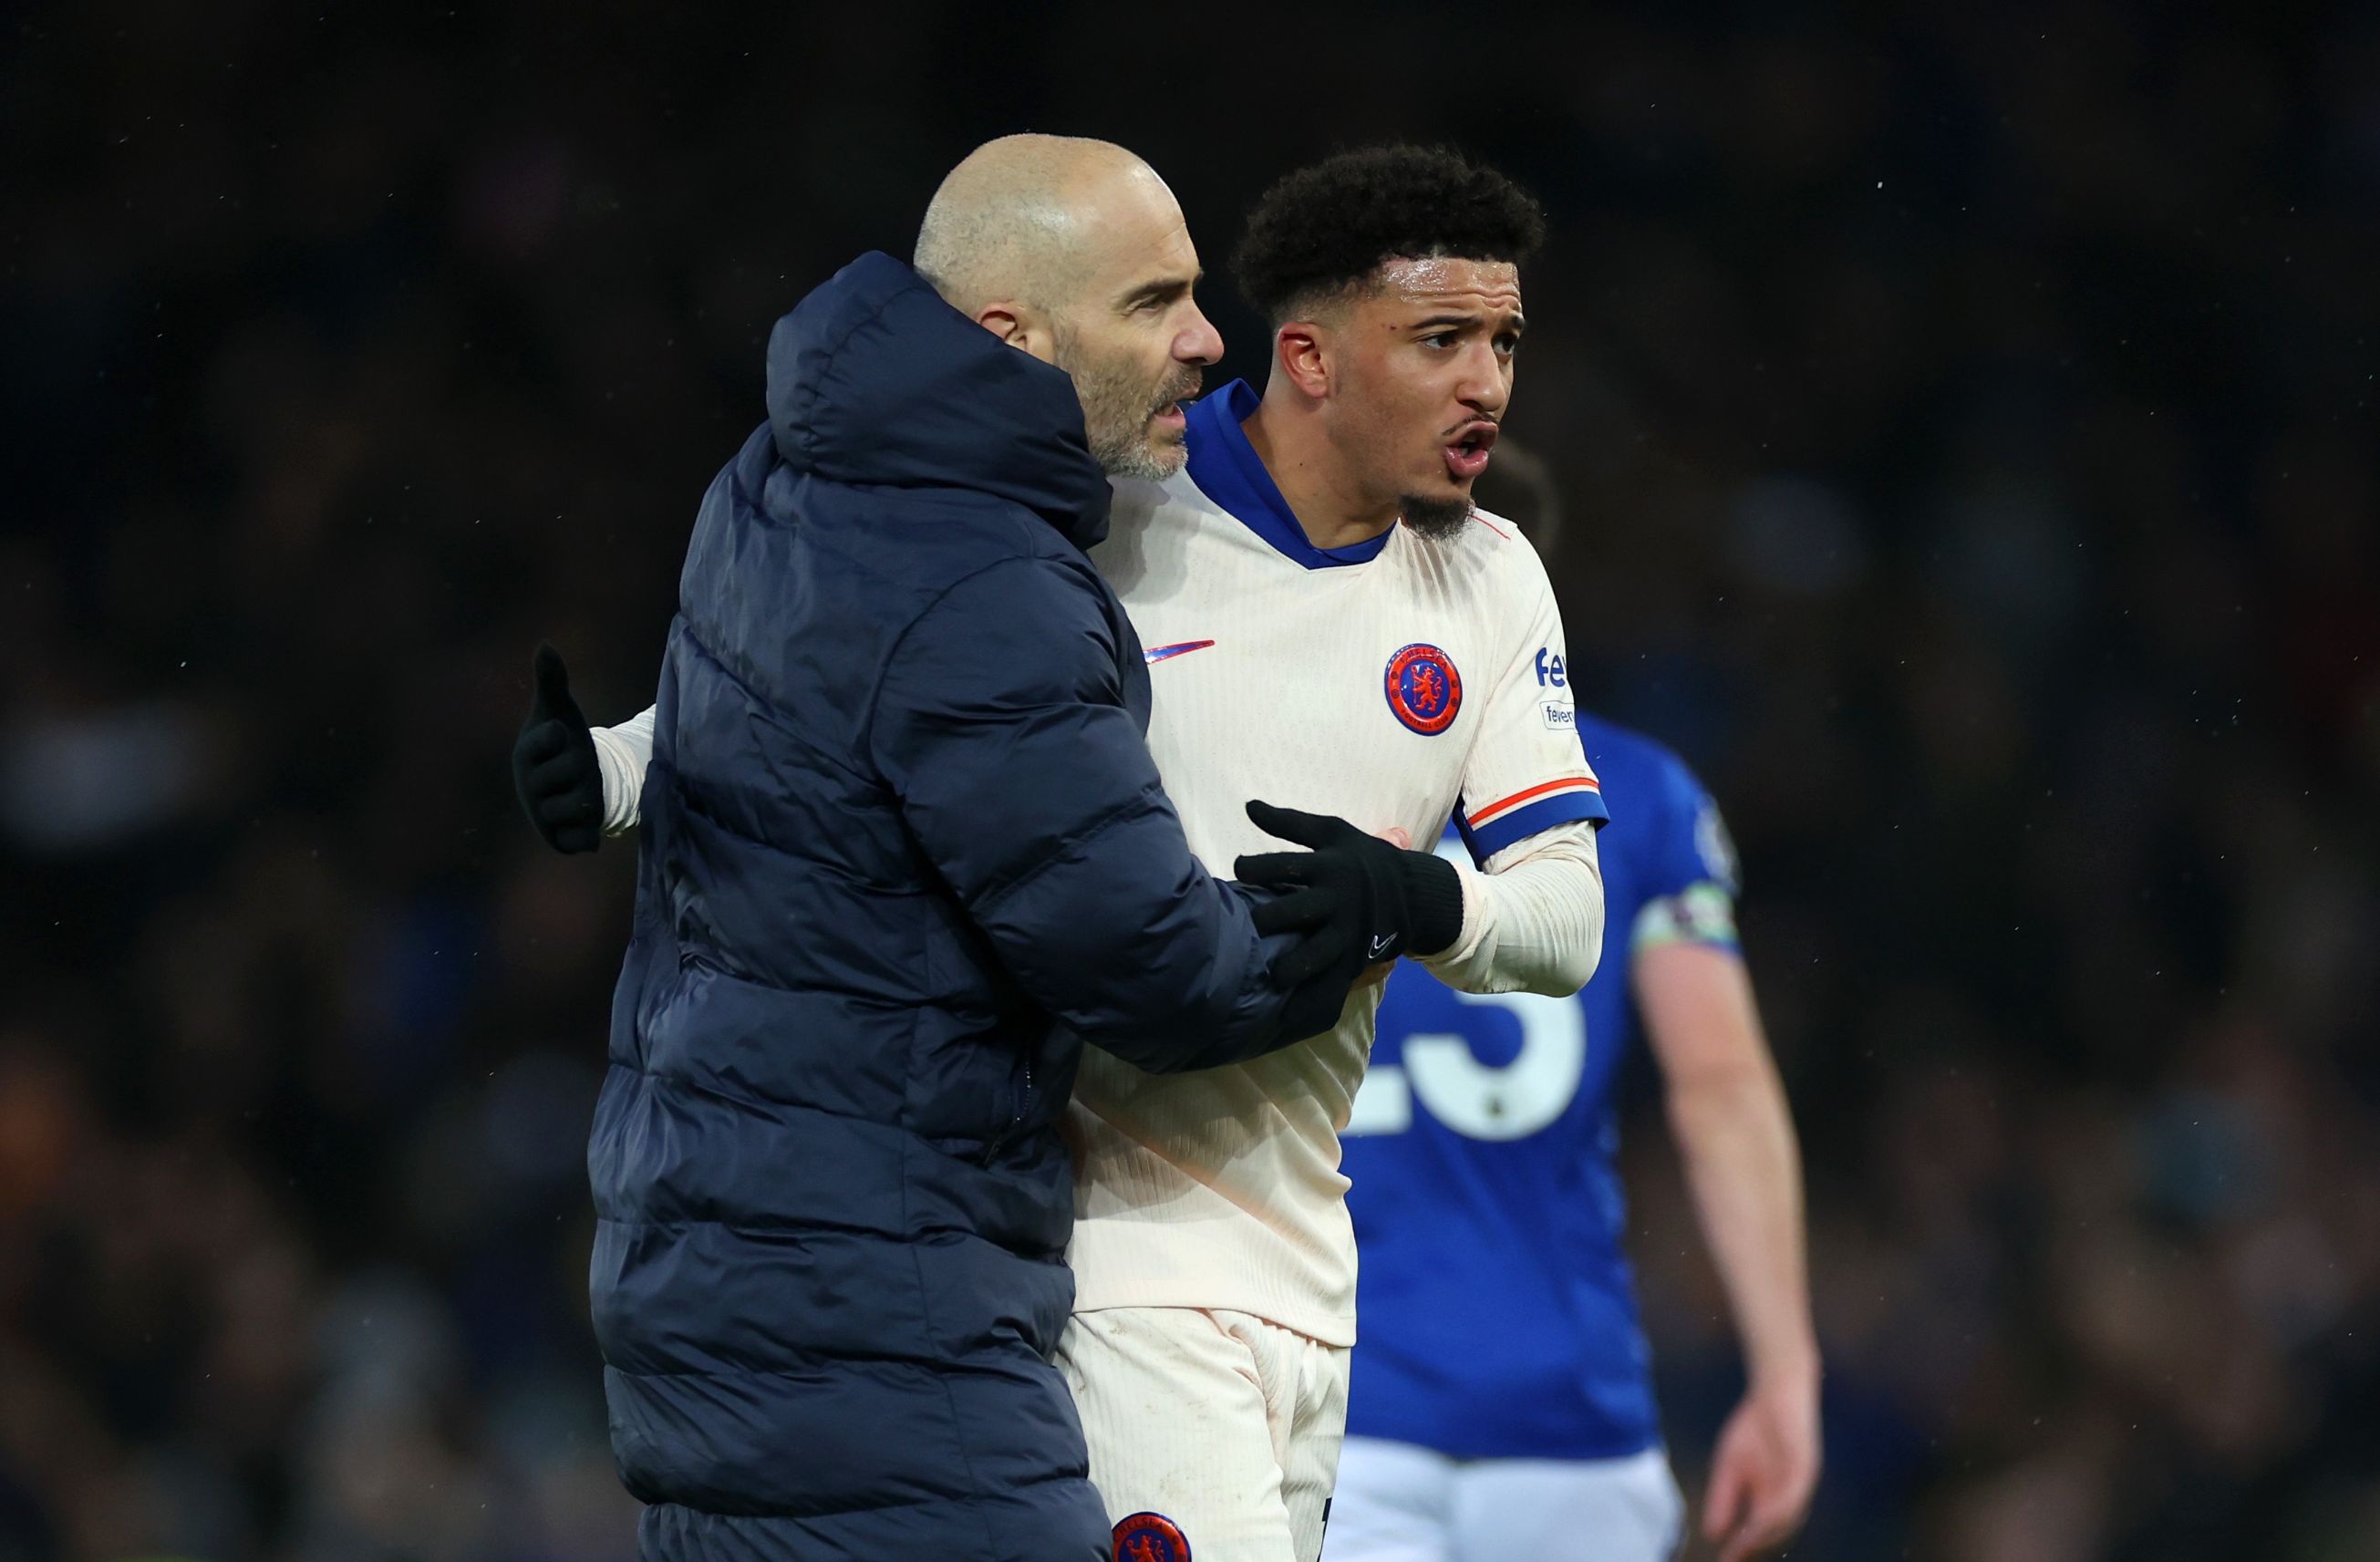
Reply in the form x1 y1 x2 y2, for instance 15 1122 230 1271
556 138 1452 1562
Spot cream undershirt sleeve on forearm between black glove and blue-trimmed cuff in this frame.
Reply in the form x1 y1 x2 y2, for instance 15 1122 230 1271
1421 819 1604 998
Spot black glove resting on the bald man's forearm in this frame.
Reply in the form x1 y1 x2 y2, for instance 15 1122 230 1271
1230 802 1464 980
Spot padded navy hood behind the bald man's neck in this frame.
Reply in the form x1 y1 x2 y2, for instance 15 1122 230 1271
769 250 1109 548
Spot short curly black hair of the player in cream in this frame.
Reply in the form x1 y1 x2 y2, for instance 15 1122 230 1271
1230 145 1545 326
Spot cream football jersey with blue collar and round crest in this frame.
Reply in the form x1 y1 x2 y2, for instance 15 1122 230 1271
1066 383 1604 1345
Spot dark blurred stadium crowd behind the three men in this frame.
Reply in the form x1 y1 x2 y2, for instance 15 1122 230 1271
0 0 2380 1562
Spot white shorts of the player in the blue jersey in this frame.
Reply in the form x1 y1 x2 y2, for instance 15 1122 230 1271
1330 1438 1685 1562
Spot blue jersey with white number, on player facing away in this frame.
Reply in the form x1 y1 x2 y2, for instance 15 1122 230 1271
1342 712 1735 1460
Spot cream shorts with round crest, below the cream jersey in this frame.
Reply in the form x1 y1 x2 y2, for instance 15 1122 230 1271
1057 1308 1350 1562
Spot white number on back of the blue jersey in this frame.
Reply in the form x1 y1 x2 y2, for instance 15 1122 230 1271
1347 993 1588 1138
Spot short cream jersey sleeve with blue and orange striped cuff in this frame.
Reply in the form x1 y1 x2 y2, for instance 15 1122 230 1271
1454 571 1611 867
